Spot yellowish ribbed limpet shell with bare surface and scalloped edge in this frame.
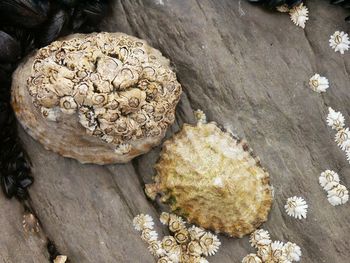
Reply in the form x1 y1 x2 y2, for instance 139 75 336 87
146 121 272 237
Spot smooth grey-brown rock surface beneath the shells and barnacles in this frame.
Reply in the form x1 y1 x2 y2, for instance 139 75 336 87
0 0 350 263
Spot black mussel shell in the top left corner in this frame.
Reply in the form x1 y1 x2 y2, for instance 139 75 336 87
0 0 50 28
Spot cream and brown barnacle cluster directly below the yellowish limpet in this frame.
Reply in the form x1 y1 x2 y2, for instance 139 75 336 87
133 212 221 263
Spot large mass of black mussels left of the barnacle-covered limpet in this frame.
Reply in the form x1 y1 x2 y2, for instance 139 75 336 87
0 0 109 200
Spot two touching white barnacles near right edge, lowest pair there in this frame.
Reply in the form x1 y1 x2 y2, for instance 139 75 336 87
319 170 349 206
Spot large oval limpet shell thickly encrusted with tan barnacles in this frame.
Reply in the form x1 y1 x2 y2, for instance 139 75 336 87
12 33 181 164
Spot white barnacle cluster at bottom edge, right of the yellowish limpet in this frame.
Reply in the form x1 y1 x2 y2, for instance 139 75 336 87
242 229 301 263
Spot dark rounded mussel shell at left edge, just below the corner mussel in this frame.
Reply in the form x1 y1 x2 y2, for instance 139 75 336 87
0 31 21 62
